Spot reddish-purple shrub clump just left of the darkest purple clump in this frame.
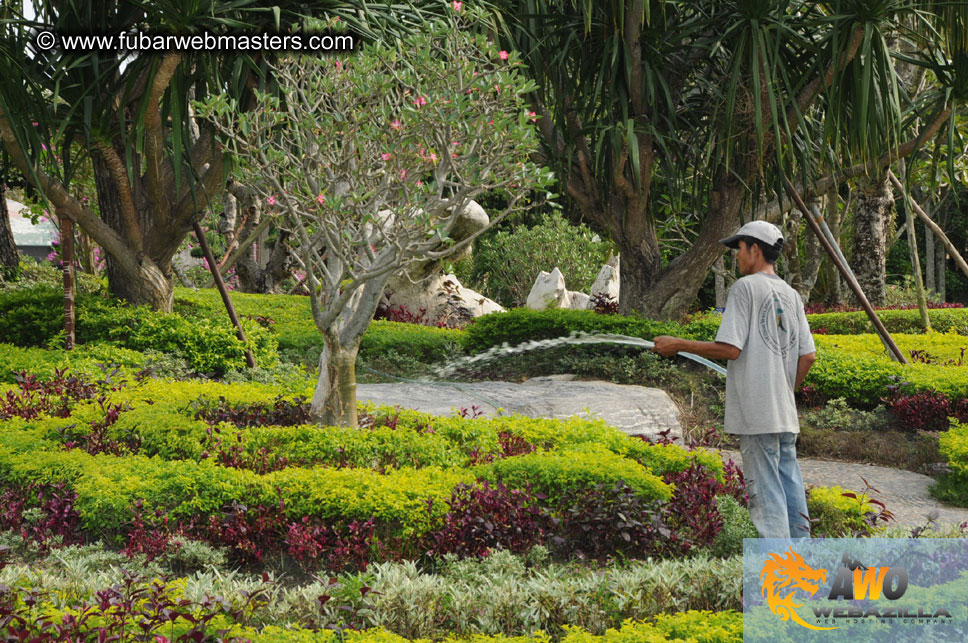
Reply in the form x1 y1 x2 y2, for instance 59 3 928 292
427 481 554 558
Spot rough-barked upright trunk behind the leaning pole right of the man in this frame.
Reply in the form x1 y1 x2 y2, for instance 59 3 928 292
851 178 894 306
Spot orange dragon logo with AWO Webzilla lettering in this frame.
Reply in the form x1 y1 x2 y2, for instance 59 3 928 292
760 547 952 630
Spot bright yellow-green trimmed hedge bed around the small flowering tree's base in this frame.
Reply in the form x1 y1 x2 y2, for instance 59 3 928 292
0 379 722 537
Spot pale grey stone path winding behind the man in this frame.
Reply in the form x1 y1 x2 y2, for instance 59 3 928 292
357 376 968 526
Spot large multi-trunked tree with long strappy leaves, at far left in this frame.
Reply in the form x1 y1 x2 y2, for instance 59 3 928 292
0 0 446 310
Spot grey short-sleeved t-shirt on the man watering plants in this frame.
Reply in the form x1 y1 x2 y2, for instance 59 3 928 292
716 272 815 435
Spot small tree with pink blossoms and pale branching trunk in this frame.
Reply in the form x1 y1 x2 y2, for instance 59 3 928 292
200 7 552 426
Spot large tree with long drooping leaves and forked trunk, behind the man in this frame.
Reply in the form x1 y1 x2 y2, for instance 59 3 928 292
498 0 966 318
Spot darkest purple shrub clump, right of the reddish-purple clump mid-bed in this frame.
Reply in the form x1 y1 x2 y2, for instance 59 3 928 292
551 481 678 559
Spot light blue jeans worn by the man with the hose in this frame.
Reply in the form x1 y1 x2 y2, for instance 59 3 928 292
739 432 810 538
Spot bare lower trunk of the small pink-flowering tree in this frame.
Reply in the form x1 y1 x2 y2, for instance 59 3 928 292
311 332 360 427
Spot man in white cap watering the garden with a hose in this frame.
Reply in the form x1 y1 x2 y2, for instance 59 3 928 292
653 221 816 538
